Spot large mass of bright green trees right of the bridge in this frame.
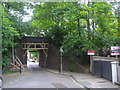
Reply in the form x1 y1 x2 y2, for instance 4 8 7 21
32 2 118 62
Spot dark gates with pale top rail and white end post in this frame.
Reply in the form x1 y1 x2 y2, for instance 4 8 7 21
92 56 120 83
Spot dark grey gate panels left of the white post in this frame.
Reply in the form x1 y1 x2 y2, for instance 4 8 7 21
92 60 112 81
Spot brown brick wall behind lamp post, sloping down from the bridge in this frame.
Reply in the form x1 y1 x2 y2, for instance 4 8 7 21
47 45 89 73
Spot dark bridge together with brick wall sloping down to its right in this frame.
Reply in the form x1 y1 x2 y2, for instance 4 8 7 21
11 37 88 72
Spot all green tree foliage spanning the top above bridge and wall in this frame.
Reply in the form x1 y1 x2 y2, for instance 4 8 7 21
0 2 119 69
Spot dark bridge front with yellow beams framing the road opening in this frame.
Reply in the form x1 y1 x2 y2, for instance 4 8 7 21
11 37 51 67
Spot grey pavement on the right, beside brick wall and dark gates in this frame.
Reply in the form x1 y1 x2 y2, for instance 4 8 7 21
46 69 118 88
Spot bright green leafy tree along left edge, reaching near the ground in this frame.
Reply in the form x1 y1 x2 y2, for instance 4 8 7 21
0 5 19 67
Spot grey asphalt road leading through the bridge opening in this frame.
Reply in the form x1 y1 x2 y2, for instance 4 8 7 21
3 62 81 88
